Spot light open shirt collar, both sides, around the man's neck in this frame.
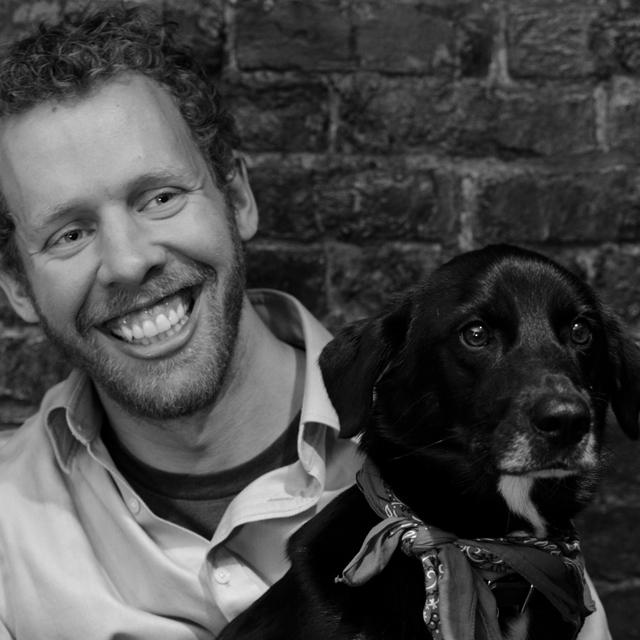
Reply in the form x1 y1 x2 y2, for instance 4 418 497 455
42 289 339 472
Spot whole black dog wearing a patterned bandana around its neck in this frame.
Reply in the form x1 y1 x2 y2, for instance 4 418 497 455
222 246 640 640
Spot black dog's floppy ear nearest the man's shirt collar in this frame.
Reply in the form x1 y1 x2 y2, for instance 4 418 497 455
320 298 411 438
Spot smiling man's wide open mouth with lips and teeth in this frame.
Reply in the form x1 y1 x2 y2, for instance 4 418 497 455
104 288 196 345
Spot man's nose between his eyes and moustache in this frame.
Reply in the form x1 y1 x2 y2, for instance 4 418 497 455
97 210 166 287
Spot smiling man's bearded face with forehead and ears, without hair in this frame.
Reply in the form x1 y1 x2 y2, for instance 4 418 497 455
0 75 257 419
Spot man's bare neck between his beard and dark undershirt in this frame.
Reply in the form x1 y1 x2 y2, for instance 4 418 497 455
98 299 304 474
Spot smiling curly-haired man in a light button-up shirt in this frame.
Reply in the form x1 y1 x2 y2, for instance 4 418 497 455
0 6 606 640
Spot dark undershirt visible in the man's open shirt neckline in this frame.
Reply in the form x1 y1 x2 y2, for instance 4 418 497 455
100 413 300 539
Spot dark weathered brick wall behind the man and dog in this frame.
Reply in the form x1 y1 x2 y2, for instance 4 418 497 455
0 0 640 640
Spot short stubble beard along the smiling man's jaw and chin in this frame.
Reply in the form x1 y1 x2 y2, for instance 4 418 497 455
33 234 245 421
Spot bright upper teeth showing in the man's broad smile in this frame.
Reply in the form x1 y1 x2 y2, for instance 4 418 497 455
111 296 188 345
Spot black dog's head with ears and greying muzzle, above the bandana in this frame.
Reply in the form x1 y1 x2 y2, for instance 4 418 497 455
320 245 640 532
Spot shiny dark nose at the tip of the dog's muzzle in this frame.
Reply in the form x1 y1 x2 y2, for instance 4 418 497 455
532 395 591 443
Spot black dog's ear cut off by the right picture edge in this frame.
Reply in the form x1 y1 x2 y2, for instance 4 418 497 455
605 314 640 440
